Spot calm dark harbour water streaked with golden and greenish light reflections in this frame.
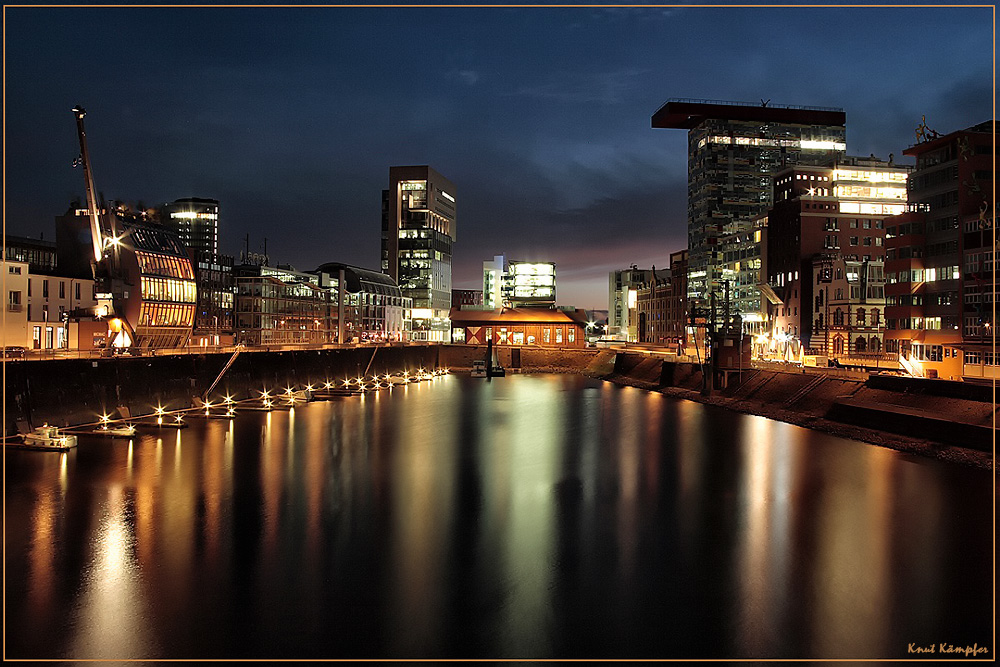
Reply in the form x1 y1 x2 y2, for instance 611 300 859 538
4 376 995 658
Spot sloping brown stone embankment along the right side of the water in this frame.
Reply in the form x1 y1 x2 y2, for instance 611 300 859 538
585 350 996 468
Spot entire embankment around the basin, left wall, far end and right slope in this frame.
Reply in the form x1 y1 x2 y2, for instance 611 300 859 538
4 345 996 468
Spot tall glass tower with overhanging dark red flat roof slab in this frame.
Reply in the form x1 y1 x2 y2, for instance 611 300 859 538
652 99 846 312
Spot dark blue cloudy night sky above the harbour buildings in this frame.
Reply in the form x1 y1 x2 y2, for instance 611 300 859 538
4 7 993 309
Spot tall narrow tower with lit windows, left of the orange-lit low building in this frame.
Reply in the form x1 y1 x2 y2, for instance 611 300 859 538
382 165 456 341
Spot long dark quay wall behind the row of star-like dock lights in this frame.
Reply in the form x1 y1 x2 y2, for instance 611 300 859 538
4 345 440 435
